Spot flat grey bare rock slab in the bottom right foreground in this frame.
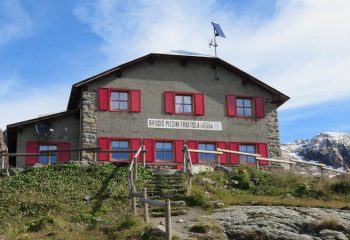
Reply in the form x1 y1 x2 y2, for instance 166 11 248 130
212 206 350 240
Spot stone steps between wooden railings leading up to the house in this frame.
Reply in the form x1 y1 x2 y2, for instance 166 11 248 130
144 170 187 217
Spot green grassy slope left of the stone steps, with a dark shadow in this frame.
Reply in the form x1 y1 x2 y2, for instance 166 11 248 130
0 164 150 240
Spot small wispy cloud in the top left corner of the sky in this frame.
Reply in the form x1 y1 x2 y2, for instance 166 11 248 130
0 0 32 46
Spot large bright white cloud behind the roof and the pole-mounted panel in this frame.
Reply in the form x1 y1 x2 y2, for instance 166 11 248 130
75 0 350 109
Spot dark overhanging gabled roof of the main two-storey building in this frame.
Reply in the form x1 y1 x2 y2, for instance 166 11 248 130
67 50 289 110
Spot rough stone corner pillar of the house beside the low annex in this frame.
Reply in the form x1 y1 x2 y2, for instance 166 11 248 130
81 91 97 161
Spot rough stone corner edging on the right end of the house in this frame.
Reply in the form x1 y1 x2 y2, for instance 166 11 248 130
265 98 281 158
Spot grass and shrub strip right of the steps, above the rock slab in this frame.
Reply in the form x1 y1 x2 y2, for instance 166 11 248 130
187 167 350 209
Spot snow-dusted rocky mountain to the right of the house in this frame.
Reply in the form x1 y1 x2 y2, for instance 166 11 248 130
281 132 350 169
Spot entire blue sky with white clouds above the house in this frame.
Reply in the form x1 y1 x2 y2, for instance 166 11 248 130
0 0 350 143
